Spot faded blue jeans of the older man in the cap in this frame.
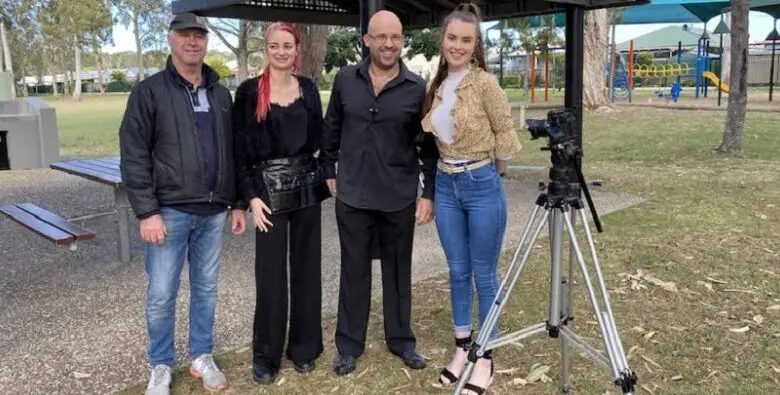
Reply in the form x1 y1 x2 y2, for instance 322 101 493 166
145 207 227 366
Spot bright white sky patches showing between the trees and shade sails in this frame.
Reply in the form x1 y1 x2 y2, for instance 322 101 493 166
103 11 780 53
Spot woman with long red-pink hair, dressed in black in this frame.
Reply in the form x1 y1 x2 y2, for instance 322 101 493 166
233 23 330 383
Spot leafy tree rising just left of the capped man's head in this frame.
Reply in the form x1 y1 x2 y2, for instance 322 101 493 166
111 0 168 81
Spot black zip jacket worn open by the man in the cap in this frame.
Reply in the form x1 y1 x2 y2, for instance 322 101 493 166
119 57 236 219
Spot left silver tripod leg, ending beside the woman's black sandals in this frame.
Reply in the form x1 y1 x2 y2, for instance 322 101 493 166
453 205 550 394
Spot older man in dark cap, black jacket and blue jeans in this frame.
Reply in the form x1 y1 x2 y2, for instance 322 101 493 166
119 14 246 395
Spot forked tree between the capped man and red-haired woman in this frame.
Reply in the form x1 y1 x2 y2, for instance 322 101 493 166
208 19 268 84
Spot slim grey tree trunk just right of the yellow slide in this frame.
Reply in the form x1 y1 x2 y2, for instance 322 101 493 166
717 0 750 154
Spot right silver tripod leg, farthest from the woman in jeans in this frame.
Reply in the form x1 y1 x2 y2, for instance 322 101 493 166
564 208 636 393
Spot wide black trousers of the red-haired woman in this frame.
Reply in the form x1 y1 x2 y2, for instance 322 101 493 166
252 205 323 369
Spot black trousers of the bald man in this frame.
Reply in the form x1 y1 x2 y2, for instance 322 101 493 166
336 200 416 357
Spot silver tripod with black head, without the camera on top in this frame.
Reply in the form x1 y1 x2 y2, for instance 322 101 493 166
454 138 637 394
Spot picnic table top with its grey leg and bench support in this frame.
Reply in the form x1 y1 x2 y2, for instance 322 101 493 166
49 156 130 263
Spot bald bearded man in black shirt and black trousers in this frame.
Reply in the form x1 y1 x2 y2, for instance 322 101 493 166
319 11 439 375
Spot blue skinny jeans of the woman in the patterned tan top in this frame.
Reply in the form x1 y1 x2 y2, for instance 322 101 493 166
434 164 507 338
